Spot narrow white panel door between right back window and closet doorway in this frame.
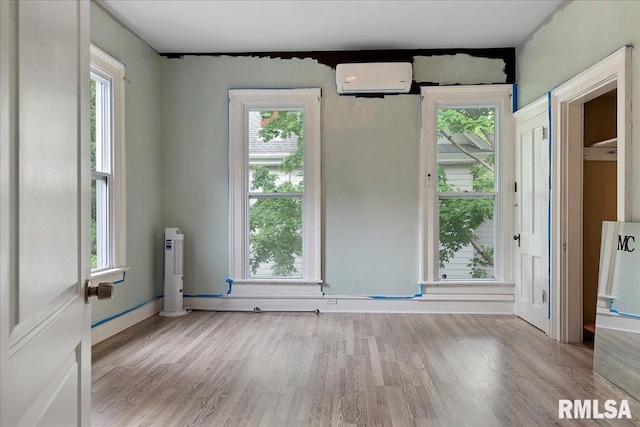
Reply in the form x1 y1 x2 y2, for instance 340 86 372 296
514 98 549 334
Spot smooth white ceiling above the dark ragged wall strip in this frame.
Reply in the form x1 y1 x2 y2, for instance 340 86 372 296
97 0 562 53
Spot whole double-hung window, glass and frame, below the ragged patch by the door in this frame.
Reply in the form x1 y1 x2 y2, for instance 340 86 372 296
421 85 513 282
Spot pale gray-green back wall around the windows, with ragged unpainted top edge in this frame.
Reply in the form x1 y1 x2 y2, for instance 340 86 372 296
161 55 506 295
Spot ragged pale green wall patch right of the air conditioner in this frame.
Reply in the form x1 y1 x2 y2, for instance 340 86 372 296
413 53 508 85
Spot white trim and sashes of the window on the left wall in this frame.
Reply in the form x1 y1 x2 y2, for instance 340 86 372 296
90 44 128 282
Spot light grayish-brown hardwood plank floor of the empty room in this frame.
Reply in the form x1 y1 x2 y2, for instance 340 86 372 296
92 311 640 427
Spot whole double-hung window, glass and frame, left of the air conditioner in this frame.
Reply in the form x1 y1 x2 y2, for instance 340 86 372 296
229 89 321 284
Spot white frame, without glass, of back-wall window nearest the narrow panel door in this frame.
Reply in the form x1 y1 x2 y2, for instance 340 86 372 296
419 85 515 285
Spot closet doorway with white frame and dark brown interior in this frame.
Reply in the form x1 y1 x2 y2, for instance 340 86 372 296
550 47 632 342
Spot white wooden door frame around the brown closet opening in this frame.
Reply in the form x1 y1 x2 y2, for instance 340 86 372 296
550 47 632 342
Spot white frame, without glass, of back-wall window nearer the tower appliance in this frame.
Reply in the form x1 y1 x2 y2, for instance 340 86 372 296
229 88 322 292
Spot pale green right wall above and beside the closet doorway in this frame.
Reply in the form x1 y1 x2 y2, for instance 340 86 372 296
517 0 640 221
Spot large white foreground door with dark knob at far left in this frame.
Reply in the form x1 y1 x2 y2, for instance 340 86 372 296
0 0 91 426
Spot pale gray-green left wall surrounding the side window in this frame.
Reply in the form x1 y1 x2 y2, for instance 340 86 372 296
91 2 163 321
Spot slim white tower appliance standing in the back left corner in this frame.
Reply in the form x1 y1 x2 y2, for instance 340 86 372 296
160 227 187 317
